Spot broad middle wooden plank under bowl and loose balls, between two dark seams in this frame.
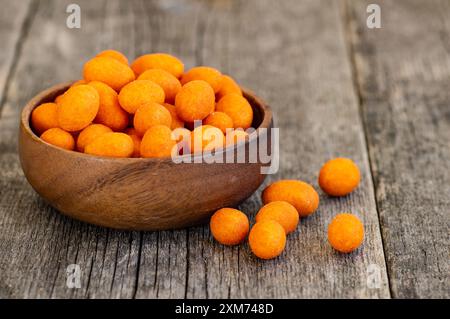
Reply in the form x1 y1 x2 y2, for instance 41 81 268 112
0 0 390 298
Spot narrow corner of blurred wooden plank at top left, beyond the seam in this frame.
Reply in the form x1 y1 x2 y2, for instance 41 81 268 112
0 0 31 114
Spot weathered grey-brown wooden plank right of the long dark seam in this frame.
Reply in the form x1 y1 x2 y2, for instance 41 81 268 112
349 0 450 298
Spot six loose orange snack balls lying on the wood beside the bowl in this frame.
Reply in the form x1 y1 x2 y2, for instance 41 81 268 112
210 158 364 259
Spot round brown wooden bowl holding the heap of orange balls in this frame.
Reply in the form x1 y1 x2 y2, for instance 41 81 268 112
19 83 272 230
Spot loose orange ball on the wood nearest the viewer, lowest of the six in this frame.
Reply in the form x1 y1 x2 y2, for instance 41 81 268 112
248 220 286 259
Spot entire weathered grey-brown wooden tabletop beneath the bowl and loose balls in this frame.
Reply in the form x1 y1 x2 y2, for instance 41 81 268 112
0 0 450 298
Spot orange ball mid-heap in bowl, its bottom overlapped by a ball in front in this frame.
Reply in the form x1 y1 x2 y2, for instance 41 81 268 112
133 102 172 136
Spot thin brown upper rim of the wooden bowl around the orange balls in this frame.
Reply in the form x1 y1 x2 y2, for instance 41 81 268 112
20 81 273 163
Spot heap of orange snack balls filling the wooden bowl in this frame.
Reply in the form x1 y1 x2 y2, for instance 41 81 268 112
31 50 253 157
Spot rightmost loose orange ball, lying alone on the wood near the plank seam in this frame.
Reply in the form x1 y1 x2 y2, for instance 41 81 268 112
328 213 364 253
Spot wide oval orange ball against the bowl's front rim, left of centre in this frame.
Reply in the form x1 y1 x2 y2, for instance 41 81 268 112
84 132 134 157
